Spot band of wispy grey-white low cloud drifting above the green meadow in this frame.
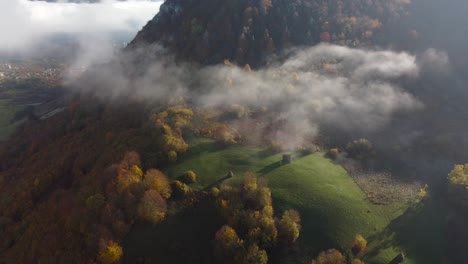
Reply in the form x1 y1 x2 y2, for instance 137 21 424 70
76 45 436 150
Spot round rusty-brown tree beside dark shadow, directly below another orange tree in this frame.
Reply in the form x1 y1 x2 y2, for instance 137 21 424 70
137 190 167 224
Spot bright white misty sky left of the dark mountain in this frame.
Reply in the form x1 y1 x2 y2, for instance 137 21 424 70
0 0 162 52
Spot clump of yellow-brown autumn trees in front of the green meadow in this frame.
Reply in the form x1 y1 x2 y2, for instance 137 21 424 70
216 172 300 263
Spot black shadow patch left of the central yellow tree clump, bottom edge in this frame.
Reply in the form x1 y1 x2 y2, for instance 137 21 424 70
123 197 223 264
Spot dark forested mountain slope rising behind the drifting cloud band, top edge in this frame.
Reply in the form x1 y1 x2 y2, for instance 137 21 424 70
130 0 407 66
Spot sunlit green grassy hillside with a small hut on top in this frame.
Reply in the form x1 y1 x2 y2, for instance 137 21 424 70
161 139 443 263
